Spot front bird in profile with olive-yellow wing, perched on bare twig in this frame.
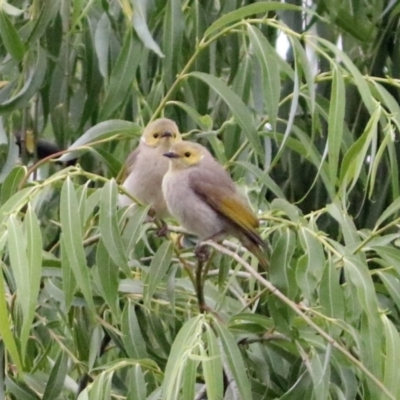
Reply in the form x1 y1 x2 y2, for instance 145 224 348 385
162 141 268 270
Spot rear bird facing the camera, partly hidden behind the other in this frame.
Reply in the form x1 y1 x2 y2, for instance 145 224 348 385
118 118 182 219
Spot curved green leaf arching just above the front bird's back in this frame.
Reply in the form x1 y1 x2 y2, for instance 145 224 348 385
188 72 263 155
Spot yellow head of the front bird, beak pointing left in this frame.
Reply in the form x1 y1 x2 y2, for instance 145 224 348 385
164 141 211 170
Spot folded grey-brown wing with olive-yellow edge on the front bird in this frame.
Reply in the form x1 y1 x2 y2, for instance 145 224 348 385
189 171 265 246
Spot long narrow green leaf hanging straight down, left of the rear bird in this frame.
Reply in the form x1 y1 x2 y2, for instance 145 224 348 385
60 178 95 313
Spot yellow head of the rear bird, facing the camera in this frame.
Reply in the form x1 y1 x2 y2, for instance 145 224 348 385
140 118 182 151
